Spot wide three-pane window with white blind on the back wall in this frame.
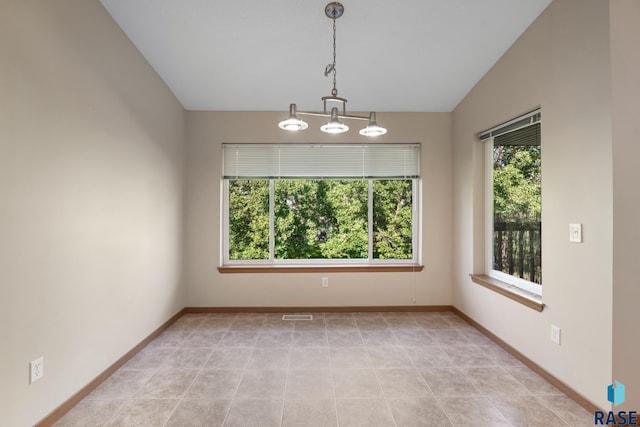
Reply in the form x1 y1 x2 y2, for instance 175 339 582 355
223 144 420 264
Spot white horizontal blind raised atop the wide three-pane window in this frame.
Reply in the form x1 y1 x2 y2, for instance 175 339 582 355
222 144 420 179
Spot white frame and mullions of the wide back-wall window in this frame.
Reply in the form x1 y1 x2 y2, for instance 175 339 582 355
220 177 422 267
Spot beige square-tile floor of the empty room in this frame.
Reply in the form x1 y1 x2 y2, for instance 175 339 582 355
55 312 593 427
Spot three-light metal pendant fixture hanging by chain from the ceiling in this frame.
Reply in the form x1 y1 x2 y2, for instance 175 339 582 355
278 2 387 136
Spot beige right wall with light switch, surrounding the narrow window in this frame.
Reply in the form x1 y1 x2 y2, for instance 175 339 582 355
453 0 612 407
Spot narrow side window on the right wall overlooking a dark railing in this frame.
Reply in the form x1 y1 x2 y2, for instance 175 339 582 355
480 110 542 295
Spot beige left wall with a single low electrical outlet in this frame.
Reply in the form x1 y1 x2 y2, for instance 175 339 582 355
0 0 184 426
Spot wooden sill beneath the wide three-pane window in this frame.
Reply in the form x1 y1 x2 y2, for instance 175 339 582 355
218 264 424 274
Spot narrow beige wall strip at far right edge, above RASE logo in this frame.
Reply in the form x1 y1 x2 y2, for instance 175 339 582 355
610 0 640 410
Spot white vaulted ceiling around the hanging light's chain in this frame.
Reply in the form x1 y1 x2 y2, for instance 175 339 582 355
100 0 551 111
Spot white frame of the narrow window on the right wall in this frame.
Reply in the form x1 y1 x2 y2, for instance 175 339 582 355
481 109 542 298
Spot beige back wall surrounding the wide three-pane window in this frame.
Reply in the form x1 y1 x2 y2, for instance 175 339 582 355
185 112 452 307
